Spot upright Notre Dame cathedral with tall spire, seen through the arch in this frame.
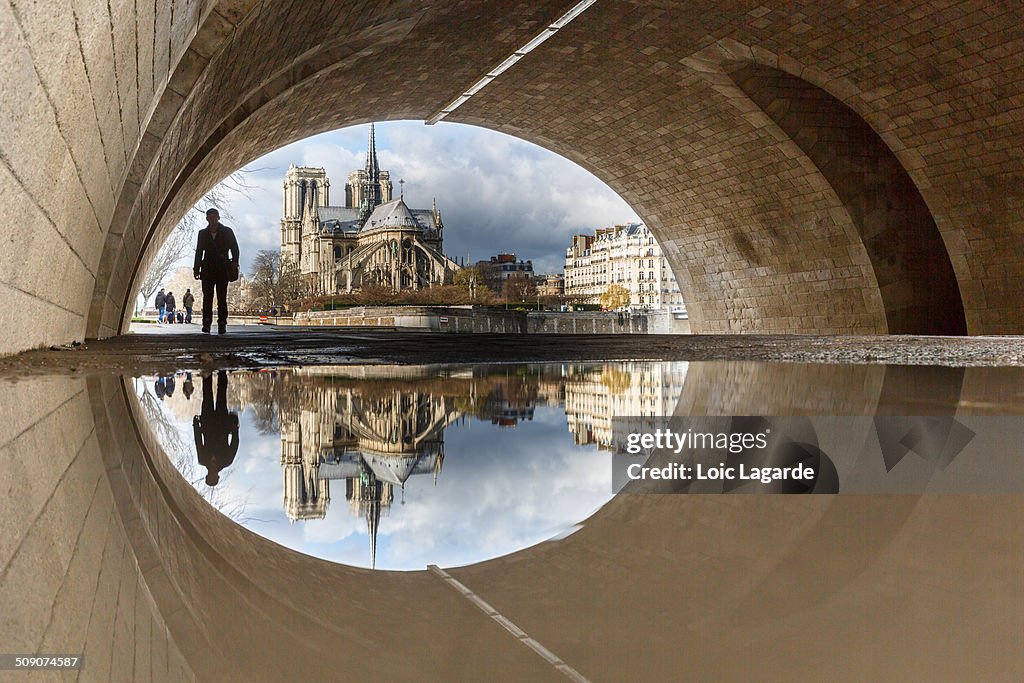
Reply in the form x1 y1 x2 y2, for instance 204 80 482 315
281 124 460 295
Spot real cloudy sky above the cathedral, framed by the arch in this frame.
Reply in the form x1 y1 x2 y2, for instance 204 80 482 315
198 121 637 272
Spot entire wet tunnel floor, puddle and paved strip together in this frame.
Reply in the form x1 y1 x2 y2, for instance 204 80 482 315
6 328 1024 681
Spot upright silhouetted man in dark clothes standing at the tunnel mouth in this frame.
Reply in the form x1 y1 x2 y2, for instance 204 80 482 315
193 209 239 335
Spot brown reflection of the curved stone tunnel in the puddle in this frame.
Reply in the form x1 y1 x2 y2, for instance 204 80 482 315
0 364 1024 681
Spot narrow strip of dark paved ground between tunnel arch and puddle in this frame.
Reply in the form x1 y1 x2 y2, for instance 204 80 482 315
0 326 1024 377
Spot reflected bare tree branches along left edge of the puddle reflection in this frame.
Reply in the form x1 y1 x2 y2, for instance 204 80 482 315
135 378 250 524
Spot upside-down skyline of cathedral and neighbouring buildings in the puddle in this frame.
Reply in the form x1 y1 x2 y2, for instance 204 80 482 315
215 362 686 567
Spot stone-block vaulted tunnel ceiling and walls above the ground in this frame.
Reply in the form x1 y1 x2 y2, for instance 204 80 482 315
0 0 1024 351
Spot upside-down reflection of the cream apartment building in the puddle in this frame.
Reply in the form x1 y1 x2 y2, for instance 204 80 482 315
565 361 687 449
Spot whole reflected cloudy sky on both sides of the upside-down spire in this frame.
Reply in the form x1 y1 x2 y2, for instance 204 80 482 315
137 382 611 569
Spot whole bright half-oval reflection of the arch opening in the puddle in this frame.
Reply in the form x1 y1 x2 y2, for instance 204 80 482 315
135 362 687 569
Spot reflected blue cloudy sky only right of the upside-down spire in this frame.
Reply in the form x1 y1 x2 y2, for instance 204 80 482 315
352 411 610 568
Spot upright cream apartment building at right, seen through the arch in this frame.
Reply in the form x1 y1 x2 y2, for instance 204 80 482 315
565 223 685 310
